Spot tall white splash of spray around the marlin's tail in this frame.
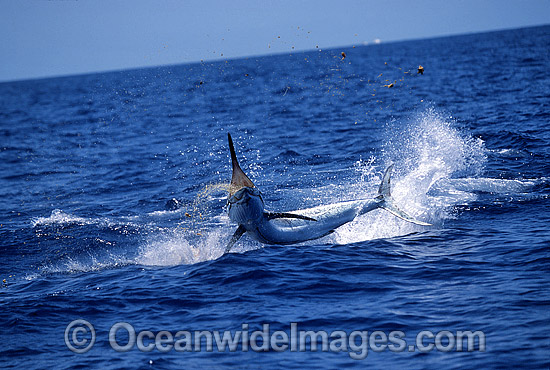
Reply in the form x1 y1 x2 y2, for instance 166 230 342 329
331 108 487 244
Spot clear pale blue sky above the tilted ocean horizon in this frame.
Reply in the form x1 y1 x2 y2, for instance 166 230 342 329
0 0 550 81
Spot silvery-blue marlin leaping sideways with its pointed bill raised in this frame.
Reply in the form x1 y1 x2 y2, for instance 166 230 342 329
224 133 430 253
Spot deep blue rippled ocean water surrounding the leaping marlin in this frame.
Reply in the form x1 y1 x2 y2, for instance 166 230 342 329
0 26 550 369
